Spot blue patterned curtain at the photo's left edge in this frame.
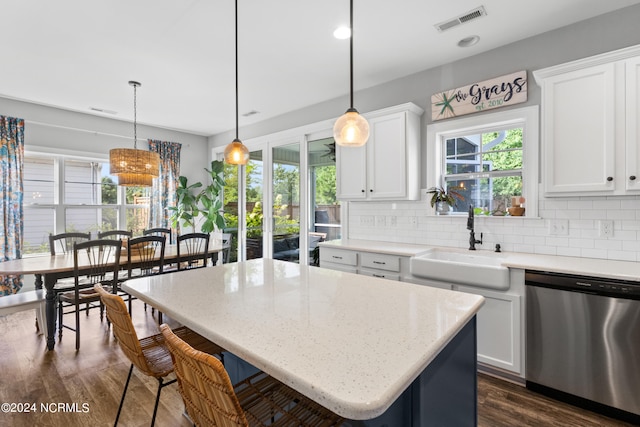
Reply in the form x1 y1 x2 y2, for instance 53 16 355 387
0 116 24 296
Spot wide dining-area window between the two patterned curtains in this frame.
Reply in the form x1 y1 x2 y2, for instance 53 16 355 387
23 154 149 254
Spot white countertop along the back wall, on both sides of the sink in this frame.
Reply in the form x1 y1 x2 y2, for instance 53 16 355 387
321 240 640 282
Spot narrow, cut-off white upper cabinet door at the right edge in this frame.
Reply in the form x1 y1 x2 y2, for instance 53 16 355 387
624 57 640 191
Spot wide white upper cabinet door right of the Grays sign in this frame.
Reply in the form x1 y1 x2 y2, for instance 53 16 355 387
542 64 615 193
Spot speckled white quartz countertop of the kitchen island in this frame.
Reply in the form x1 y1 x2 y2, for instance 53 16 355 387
123 259 484 419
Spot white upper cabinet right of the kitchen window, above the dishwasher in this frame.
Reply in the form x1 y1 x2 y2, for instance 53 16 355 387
533 47 640 196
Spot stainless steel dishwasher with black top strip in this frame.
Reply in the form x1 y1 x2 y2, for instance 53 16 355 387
525 271 640 424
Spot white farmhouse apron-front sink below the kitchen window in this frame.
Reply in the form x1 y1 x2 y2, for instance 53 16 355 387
409 249 509 290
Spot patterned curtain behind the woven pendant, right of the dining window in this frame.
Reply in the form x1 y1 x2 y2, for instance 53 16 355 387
149 139 182 241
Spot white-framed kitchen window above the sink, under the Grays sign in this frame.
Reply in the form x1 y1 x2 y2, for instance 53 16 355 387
427 107 538 216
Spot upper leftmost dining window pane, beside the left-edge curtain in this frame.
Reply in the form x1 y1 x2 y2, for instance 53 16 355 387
24 157 55 205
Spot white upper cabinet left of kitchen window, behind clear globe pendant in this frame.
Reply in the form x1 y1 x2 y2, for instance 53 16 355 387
337 103 423 200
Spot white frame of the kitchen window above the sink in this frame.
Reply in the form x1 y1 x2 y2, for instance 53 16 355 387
425 106 540 218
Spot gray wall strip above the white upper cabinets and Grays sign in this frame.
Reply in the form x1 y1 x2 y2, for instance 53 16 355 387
209 1 640 187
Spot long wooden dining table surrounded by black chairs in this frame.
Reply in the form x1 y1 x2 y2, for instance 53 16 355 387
0 240 228 350
